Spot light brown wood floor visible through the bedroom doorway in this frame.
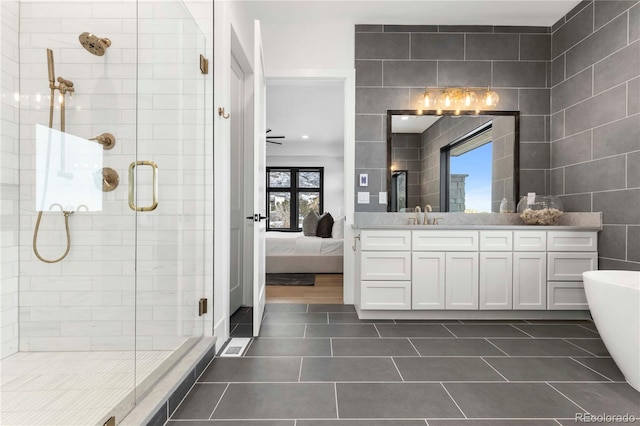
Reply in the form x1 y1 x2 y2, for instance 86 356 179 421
267 274 344 304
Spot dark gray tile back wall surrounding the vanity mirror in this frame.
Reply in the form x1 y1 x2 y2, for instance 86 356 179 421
355 25 552 212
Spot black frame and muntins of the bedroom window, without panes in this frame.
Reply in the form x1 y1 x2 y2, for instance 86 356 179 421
266 166 324 232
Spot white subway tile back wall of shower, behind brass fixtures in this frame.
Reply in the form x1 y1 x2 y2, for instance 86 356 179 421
19 2 205 351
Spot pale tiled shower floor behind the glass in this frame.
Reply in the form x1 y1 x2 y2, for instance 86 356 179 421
0 339 198 426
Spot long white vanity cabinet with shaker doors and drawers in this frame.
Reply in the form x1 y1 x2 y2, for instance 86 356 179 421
356 227 598 318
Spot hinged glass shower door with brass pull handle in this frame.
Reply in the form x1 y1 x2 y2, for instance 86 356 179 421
128 1 205 396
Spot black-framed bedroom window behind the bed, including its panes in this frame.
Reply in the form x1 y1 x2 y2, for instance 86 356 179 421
267 167 324 232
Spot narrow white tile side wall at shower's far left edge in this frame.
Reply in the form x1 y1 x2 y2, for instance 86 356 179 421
0 0 20 359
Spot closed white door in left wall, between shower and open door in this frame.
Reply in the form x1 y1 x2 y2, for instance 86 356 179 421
229 55 245 315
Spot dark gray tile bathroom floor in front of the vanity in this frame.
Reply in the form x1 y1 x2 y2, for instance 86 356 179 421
167 304 640 426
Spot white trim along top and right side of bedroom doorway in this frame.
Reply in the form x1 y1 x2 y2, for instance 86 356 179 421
265 68 356 304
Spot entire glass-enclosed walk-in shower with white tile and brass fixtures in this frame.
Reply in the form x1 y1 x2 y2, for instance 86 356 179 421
1 0 207 425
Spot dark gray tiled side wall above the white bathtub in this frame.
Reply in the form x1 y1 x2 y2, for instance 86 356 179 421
551 0 640 270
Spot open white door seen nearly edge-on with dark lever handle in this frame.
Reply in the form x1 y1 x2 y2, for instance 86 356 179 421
253 21 267 336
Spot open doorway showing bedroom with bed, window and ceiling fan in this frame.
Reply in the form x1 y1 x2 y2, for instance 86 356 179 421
265 78 345 304
